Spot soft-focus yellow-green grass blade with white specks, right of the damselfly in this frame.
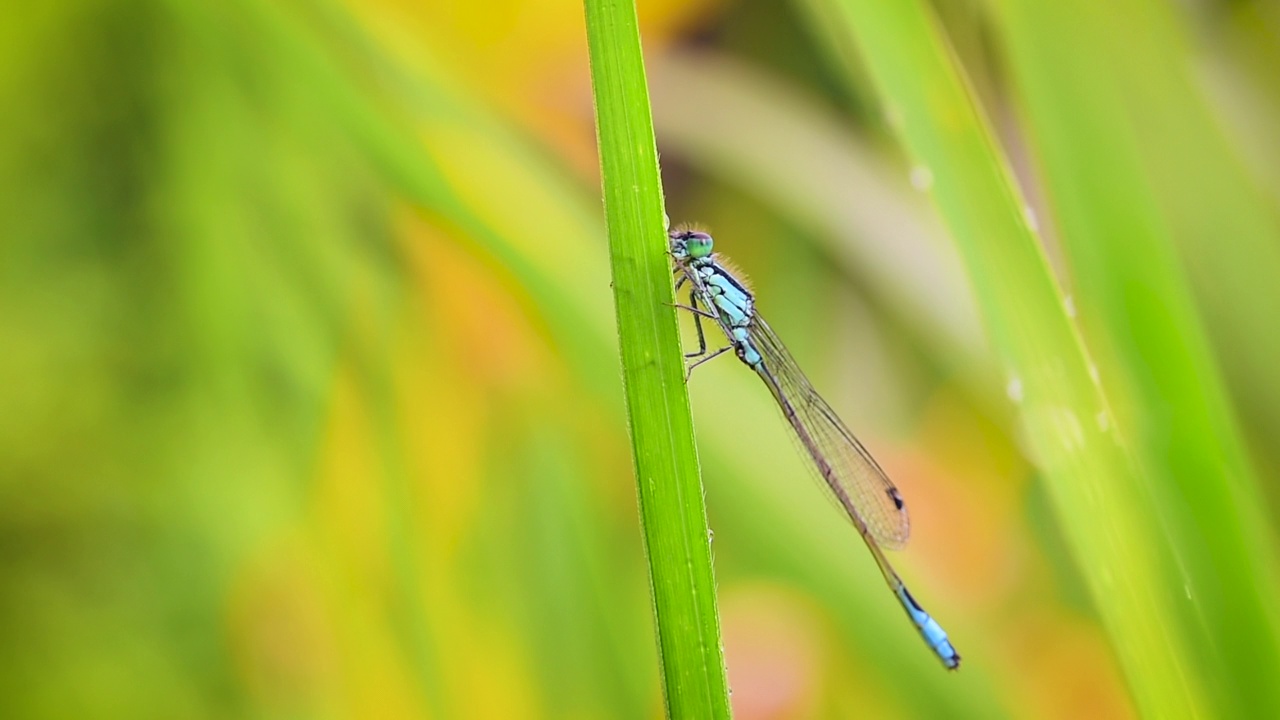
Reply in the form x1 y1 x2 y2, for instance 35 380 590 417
814 0 1207 717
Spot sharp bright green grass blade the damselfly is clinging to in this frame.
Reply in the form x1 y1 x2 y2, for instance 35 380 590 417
585 0 730 717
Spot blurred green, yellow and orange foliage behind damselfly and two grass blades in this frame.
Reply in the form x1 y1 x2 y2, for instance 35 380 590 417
0 0 1280 717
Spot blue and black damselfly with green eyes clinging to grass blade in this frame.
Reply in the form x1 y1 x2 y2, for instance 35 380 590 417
669 229 960 670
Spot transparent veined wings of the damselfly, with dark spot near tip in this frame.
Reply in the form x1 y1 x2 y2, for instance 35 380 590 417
749 315 911 550
